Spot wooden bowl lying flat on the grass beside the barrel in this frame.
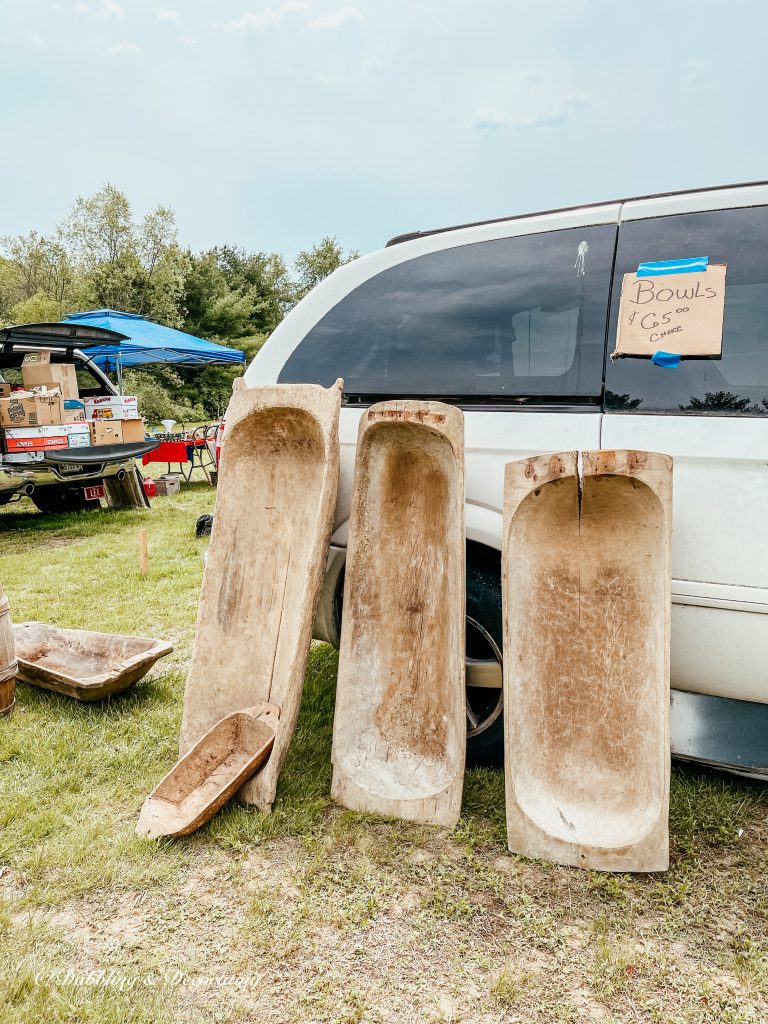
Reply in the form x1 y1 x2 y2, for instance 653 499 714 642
13 623 173 700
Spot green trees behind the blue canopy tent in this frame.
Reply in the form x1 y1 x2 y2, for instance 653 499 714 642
0 183 359 422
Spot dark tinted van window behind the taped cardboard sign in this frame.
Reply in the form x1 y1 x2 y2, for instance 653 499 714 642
605 207 768 416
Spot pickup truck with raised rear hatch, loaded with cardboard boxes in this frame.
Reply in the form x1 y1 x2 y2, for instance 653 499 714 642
0 324 158 512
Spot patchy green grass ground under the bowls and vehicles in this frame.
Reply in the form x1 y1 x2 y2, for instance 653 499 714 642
0 491 768 1024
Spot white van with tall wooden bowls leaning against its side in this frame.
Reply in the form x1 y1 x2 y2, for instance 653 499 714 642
246 183 768 774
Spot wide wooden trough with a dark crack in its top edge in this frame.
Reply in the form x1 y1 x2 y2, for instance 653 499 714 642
503 451 672 871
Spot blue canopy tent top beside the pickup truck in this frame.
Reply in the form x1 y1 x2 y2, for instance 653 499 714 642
61 309 246 377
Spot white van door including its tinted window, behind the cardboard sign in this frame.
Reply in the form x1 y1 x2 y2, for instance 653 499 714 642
602 204 768 702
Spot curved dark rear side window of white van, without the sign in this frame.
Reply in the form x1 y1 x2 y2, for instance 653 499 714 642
279 225 615 401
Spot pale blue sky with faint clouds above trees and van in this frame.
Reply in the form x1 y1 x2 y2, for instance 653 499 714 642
0 0 768 258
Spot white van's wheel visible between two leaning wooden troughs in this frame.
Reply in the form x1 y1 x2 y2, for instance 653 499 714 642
466 543 504 768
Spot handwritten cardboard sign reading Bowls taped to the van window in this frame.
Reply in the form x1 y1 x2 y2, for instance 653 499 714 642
613 263 725 356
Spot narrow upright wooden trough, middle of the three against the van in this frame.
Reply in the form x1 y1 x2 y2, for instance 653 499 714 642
332 401 466 826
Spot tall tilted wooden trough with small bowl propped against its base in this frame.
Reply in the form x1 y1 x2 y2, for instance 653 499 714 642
179 379 341 811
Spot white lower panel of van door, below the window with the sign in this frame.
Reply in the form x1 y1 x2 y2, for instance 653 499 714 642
602 414 768 702
